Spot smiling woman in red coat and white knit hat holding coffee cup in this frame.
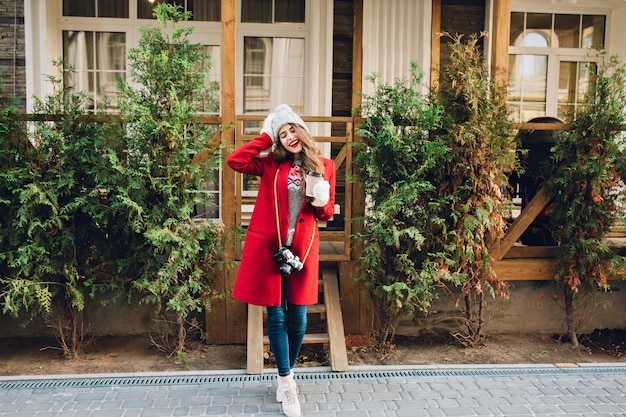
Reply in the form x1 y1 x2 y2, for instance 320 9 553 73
226 104 335 417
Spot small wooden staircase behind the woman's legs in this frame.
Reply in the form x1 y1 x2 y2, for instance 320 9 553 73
247 265 348 374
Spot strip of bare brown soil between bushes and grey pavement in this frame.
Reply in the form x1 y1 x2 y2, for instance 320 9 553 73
0 330 626 375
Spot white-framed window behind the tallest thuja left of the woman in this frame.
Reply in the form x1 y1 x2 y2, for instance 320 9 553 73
56 0 221 219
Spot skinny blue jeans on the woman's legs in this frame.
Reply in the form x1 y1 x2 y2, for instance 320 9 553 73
267 301 307 376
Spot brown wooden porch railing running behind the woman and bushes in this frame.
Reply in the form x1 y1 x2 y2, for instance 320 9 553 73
20 114 626 280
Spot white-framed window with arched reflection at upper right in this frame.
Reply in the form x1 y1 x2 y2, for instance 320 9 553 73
508 12 606 122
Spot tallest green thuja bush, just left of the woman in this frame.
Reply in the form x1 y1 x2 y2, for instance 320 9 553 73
113 4 220 359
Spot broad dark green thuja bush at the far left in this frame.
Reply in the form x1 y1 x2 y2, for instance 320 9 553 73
0 62 120 356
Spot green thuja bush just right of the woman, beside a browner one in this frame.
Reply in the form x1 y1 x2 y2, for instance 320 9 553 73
355 64 452 348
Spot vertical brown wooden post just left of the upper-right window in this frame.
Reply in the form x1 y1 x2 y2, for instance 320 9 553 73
491 0 511 85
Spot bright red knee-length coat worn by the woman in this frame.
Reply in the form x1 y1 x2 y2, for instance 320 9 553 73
226 134 335 306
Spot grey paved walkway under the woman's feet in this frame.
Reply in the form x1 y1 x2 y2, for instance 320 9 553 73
0 363 626 417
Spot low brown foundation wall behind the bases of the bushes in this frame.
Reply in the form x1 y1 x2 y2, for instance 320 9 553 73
0 281 626 343
